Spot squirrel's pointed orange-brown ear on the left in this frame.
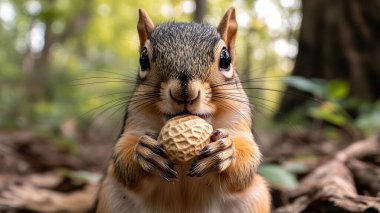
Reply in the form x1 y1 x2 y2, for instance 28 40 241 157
137 8 154 51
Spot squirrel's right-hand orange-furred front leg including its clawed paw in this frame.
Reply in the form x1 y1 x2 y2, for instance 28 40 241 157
188 129 261 191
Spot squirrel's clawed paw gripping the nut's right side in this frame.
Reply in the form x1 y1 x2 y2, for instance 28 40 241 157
188 129 235 177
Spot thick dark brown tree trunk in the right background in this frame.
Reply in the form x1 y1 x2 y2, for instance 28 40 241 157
279 0 380 117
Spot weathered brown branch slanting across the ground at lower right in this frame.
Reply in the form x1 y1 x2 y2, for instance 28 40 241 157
274 135 380 213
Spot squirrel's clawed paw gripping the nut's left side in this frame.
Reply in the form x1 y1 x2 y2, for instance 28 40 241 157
135 134 177 181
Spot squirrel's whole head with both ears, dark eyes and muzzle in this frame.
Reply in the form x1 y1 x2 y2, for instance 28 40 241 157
131 8 249 127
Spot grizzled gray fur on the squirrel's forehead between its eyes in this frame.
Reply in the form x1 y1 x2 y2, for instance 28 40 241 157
149 23 220 80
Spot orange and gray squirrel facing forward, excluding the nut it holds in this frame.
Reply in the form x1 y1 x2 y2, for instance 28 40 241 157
95 8 271 213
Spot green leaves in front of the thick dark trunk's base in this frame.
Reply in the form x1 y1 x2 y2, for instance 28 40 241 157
286 76 380 135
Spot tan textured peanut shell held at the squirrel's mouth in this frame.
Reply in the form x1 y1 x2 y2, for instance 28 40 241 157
158 115 213 164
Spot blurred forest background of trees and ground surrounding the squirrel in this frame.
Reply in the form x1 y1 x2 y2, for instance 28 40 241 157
0 0 380 212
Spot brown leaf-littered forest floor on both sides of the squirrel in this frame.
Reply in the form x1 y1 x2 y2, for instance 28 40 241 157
0 127 380 212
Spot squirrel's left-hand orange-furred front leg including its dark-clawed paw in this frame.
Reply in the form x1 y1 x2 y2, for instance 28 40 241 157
113 131 177 188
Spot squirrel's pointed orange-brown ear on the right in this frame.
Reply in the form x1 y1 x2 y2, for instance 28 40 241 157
218 7 238 51
